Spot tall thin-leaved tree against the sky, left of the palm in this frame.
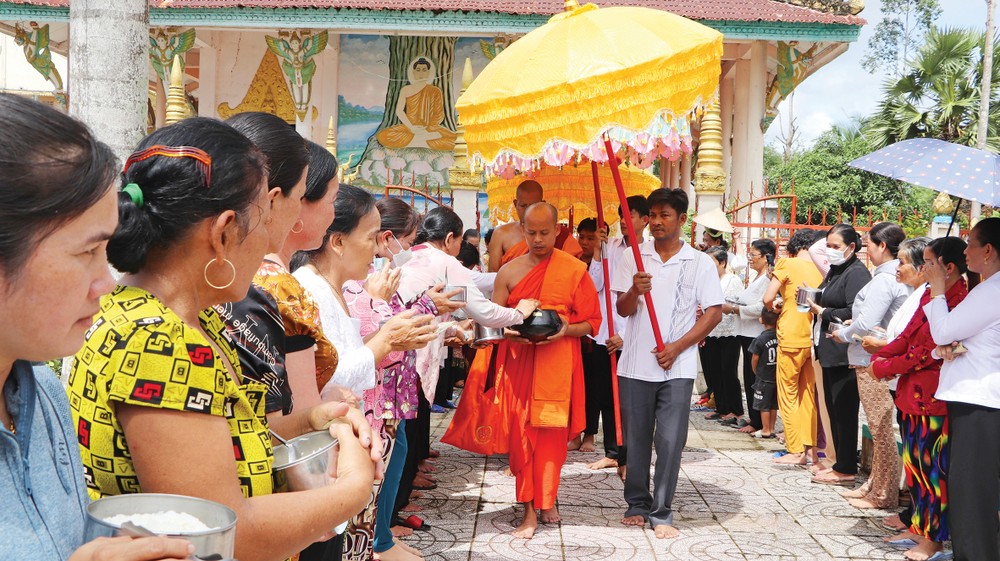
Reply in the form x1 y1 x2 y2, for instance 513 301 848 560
861 0 941 76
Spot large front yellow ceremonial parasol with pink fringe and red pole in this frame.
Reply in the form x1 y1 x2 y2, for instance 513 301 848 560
456 0 722 443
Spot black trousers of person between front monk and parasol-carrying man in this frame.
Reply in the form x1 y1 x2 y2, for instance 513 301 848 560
580 337 618 460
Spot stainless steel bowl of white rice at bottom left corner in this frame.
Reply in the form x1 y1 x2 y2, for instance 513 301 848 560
83 493 236 559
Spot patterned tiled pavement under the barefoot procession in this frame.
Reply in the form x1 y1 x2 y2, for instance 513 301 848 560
406 396 903 561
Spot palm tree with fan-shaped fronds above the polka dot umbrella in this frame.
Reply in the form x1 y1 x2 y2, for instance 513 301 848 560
864 28 1000 151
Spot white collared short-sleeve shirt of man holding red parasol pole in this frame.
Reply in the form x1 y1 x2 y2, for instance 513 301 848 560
611 240 724 382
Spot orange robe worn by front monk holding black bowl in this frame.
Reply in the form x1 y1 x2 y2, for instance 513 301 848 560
441 250 601 510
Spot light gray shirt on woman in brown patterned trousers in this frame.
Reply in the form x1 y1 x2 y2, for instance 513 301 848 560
837 259 910 366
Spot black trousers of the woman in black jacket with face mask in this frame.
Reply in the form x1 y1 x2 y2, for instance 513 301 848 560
823 366 861 475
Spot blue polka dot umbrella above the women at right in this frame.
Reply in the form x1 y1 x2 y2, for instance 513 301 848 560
848 138 1000 206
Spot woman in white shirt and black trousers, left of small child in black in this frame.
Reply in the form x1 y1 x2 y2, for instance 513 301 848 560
722 239 777 434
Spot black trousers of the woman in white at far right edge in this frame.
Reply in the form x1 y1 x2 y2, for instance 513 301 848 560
948 401 1000 561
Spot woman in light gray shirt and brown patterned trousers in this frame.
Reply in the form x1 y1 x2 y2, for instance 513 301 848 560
833 222 910 509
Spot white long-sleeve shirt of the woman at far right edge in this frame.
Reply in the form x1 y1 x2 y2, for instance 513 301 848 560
924 274 1000 409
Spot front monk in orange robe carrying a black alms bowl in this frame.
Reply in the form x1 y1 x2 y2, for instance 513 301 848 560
442 203 601 538
